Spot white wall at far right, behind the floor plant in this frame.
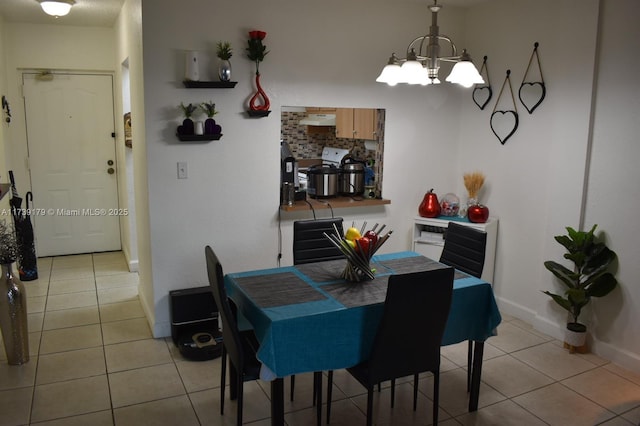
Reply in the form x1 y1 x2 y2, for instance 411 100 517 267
585 0 640 366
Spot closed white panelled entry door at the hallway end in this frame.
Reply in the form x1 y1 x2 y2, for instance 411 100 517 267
20 73 121 256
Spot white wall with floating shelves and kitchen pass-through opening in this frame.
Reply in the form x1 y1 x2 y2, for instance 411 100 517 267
140 0 462 335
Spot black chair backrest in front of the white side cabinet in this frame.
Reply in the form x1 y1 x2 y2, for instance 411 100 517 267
440 222 487 278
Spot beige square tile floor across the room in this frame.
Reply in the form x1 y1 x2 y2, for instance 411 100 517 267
0 252 640 426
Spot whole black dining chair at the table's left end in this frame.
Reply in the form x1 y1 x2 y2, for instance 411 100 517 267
204 246 261 426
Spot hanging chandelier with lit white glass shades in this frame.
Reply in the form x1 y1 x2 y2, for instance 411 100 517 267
376 0 484 87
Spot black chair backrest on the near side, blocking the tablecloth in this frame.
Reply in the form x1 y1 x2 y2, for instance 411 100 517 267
369 267 454 385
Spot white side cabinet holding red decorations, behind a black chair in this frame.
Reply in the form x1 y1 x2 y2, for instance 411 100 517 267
413 216 498 283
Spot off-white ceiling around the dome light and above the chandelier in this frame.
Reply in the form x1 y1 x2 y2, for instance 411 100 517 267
0 0 487 27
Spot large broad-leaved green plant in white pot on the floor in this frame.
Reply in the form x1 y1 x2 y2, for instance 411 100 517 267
544 225 618 352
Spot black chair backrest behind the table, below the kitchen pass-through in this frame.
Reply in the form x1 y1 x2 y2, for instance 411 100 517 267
293 217 344 265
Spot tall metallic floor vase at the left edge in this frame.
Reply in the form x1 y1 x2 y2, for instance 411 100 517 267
0 264 29 365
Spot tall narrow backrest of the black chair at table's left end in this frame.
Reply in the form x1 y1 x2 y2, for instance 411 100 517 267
204 246 244 369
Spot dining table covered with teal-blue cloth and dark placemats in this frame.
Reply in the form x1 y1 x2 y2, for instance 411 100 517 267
223 251 501 425
